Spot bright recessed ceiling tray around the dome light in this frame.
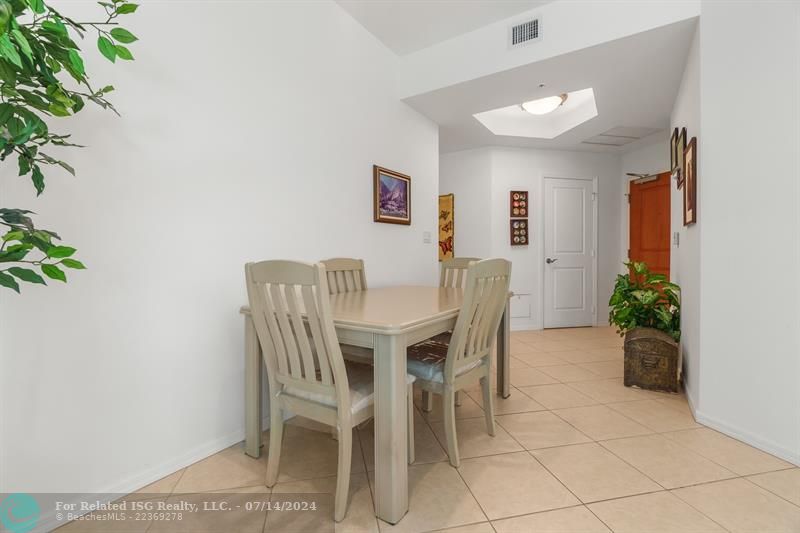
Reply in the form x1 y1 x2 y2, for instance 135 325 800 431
474 88 597 139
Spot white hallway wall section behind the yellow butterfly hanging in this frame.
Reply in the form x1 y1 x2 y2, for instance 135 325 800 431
439 149 492 257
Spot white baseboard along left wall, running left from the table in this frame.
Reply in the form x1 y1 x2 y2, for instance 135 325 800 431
37 417 269 531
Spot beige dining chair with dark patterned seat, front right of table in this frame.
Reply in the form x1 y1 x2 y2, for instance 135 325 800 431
407 259 511 467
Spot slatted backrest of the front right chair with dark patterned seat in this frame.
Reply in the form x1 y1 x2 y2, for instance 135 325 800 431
444 259 511 382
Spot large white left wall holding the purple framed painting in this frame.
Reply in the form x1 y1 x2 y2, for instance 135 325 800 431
0 2 439 492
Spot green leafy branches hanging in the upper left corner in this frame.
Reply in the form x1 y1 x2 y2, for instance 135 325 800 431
0 0 139 292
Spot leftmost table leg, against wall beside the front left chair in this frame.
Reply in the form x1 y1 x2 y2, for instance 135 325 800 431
244 315 264 458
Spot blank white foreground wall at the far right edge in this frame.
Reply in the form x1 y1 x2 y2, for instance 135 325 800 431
697 1 800 464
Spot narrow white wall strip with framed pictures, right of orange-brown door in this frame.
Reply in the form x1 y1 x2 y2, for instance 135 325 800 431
669 23 705 408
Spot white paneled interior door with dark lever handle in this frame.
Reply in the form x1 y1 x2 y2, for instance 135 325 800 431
542 178 595 328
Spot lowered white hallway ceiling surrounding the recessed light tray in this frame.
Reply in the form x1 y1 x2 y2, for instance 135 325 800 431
405 19 696 153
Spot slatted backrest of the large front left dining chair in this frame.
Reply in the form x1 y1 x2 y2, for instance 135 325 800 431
245 261 350 412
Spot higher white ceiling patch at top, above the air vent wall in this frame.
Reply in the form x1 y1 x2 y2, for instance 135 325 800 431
336 0 550 55
